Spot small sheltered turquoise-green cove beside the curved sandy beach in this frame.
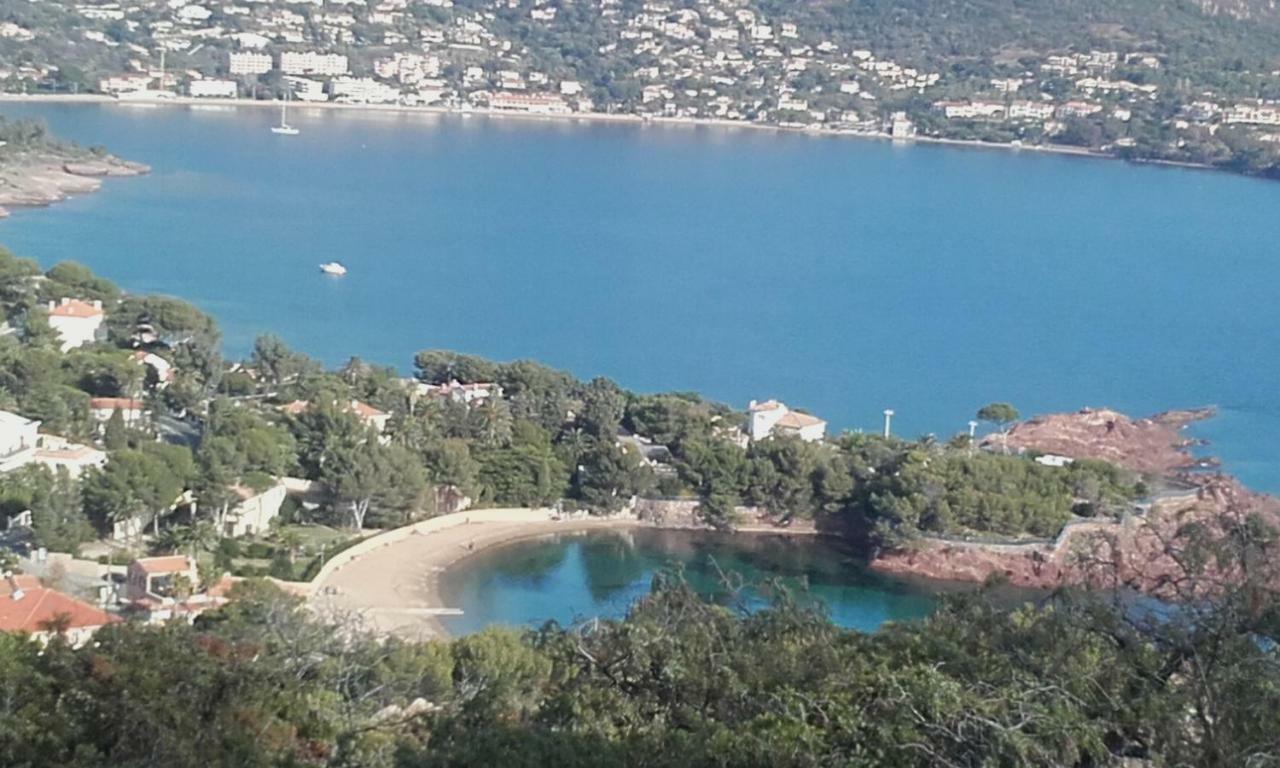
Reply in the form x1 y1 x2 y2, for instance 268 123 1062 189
440 530 940 635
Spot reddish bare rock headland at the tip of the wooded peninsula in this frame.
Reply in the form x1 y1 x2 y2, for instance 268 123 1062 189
872 408 1280 598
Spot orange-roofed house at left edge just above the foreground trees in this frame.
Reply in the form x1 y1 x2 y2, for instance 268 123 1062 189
0 573 120 648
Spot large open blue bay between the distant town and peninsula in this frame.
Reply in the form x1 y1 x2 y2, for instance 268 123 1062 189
0 105 1280 490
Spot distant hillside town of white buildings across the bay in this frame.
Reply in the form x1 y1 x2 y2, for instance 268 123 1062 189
0 0 1280 175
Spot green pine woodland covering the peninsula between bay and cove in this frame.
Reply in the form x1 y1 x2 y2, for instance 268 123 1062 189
0 253 1143 576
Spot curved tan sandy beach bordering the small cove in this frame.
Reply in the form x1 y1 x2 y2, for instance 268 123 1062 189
310 513 644 640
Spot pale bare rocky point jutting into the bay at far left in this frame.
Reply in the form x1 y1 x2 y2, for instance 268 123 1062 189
0 154 151 218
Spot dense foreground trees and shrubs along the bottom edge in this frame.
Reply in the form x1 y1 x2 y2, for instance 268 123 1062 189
0 577 1280 768
